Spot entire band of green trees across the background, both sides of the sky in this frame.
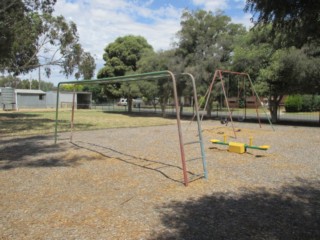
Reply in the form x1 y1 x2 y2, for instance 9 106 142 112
0 0 320 122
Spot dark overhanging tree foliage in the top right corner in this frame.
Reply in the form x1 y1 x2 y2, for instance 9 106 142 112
245 0 320 48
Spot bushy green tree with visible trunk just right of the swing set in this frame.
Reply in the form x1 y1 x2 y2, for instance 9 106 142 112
232 25 320 122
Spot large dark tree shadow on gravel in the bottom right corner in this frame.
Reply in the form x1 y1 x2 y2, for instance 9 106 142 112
150 179 320 240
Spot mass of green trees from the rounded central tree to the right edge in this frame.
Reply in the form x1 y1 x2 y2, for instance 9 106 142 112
98 0 320 122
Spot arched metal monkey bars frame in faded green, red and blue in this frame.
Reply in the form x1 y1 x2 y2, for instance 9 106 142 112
54 71 208 186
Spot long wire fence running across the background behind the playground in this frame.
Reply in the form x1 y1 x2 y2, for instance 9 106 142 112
3 100 320 126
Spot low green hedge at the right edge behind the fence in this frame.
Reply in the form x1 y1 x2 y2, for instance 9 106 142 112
284 95 320 112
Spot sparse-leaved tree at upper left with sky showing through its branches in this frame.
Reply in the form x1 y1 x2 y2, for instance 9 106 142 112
0 0 94 79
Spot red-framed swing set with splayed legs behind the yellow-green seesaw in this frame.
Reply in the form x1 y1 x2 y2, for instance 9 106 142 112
201 70 274 138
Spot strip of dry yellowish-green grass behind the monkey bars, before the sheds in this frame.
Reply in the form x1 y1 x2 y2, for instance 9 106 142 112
0 110 175 136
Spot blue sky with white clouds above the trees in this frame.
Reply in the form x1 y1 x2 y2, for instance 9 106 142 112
35 0 251 85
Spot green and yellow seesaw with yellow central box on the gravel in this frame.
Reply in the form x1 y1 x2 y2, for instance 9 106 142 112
210 135 270 153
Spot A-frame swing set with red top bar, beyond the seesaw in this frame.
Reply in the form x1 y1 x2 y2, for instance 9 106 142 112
201 70 274 138
